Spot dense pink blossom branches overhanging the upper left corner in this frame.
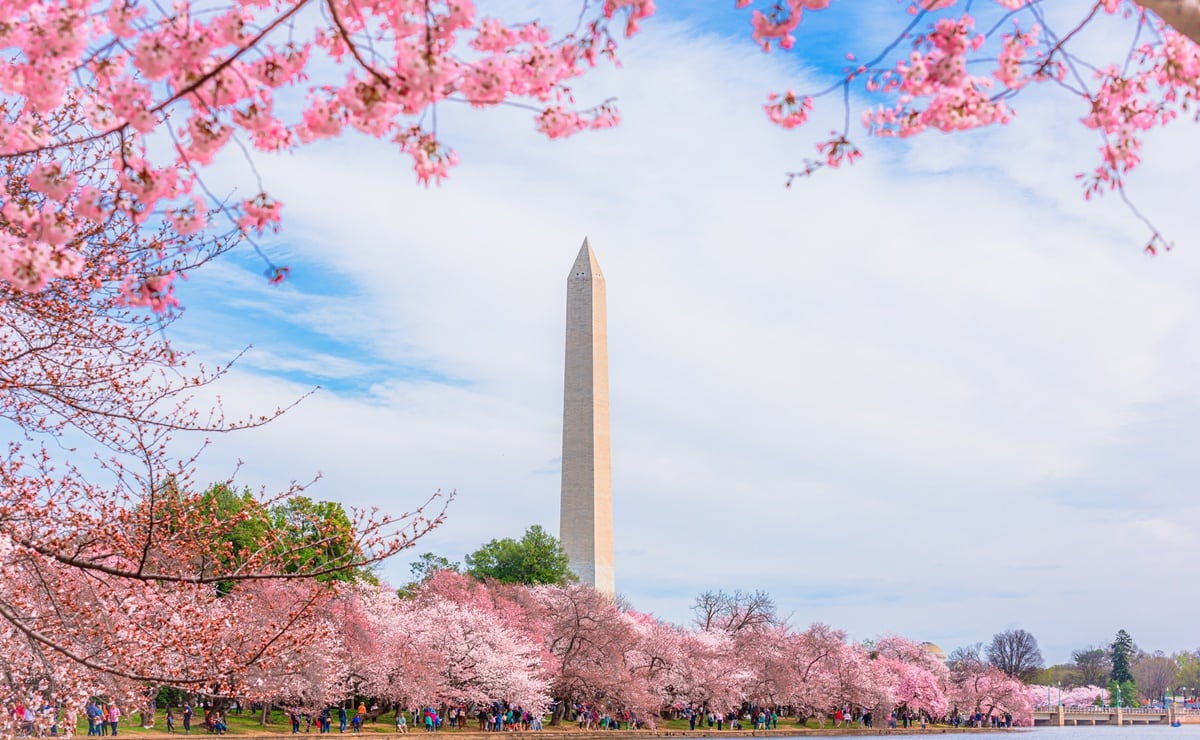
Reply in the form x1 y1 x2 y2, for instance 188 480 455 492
0 0 654 299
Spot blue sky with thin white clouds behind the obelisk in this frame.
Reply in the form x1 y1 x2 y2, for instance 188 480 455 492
170 2 1200 663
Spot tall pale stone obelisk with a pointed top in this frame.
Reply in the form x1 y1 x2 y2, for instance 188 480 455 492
558 239 613 595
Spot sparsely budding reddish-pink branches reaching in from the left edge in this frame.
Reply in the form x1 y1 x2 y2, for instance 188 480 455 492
0 219 440 729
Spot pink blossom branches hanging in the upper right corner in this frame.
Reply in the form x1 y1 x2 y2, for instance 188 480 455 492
737 0 1200 253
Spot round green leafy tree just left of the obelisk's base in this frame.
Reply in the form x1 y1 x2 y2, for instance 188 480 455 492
466 524 577 585
